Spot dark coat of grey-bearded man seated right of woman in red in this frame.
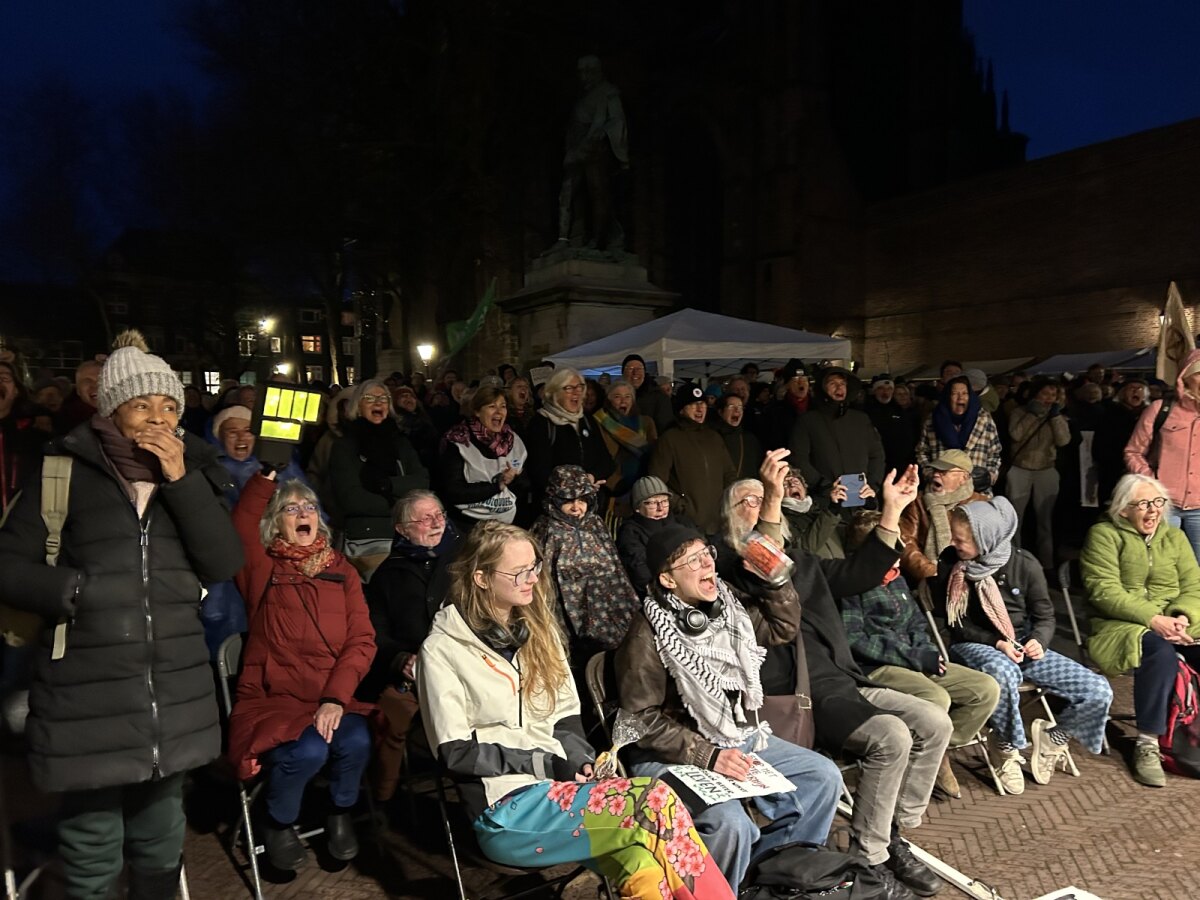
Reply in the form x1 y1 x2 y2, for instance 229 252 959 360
358 523 460 701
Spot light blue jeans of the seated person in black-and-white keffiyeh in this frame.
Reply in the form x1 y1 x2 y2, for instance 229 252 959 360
631 734 841 893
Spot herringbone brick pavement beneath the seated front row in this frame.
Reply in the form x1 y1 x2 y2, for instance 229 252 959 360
2 633 1200 900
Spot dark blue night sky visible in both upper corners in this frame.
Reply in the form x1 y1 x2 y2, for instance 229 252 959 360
0 0 1200 165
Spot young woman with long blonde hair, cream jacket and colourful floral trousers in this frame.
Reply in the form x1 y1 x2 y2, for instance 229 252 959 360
416 522 733 900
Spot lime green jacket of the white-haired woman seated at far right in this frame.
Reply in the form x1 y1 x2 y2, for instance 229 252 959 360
1079 518 1200 674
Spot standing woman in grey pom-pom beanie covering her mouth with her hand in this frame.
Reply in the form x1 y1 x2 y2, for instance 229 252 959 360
0 331 242 900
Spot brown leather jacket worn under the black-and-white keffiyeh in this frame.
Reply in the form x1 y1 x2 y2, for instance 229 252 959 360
616 581 800 769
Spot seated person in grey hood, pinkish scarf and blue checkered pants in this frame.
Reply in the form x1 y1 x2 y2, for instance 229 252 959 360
934 497 1112 793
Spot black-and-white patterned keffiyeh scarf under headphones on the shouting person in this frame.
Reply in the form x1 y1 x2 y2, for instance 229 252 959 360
642 578 770 750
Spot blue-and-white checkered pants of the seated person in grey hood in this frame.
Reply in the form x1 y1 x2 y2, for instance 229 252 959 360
950 643 1112 754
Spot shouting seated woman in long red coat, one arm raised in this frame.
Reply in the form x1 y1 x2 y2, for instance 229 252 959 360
229 473 376 870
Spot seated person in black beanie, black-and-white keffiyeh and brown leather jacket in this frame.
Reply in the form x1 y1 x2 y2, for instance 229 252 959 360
614 524 841 886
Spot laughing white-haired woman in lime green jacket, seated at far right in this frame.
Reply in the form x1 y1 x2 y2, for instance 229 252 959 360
1080 475 1200 787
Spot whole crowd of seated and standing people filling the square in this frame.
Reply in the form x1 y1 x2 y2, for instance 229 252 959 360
0 332 1200 900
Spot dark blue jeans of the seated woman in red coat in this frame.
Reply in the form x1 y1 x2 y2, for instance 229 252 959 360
264 713 371 824
